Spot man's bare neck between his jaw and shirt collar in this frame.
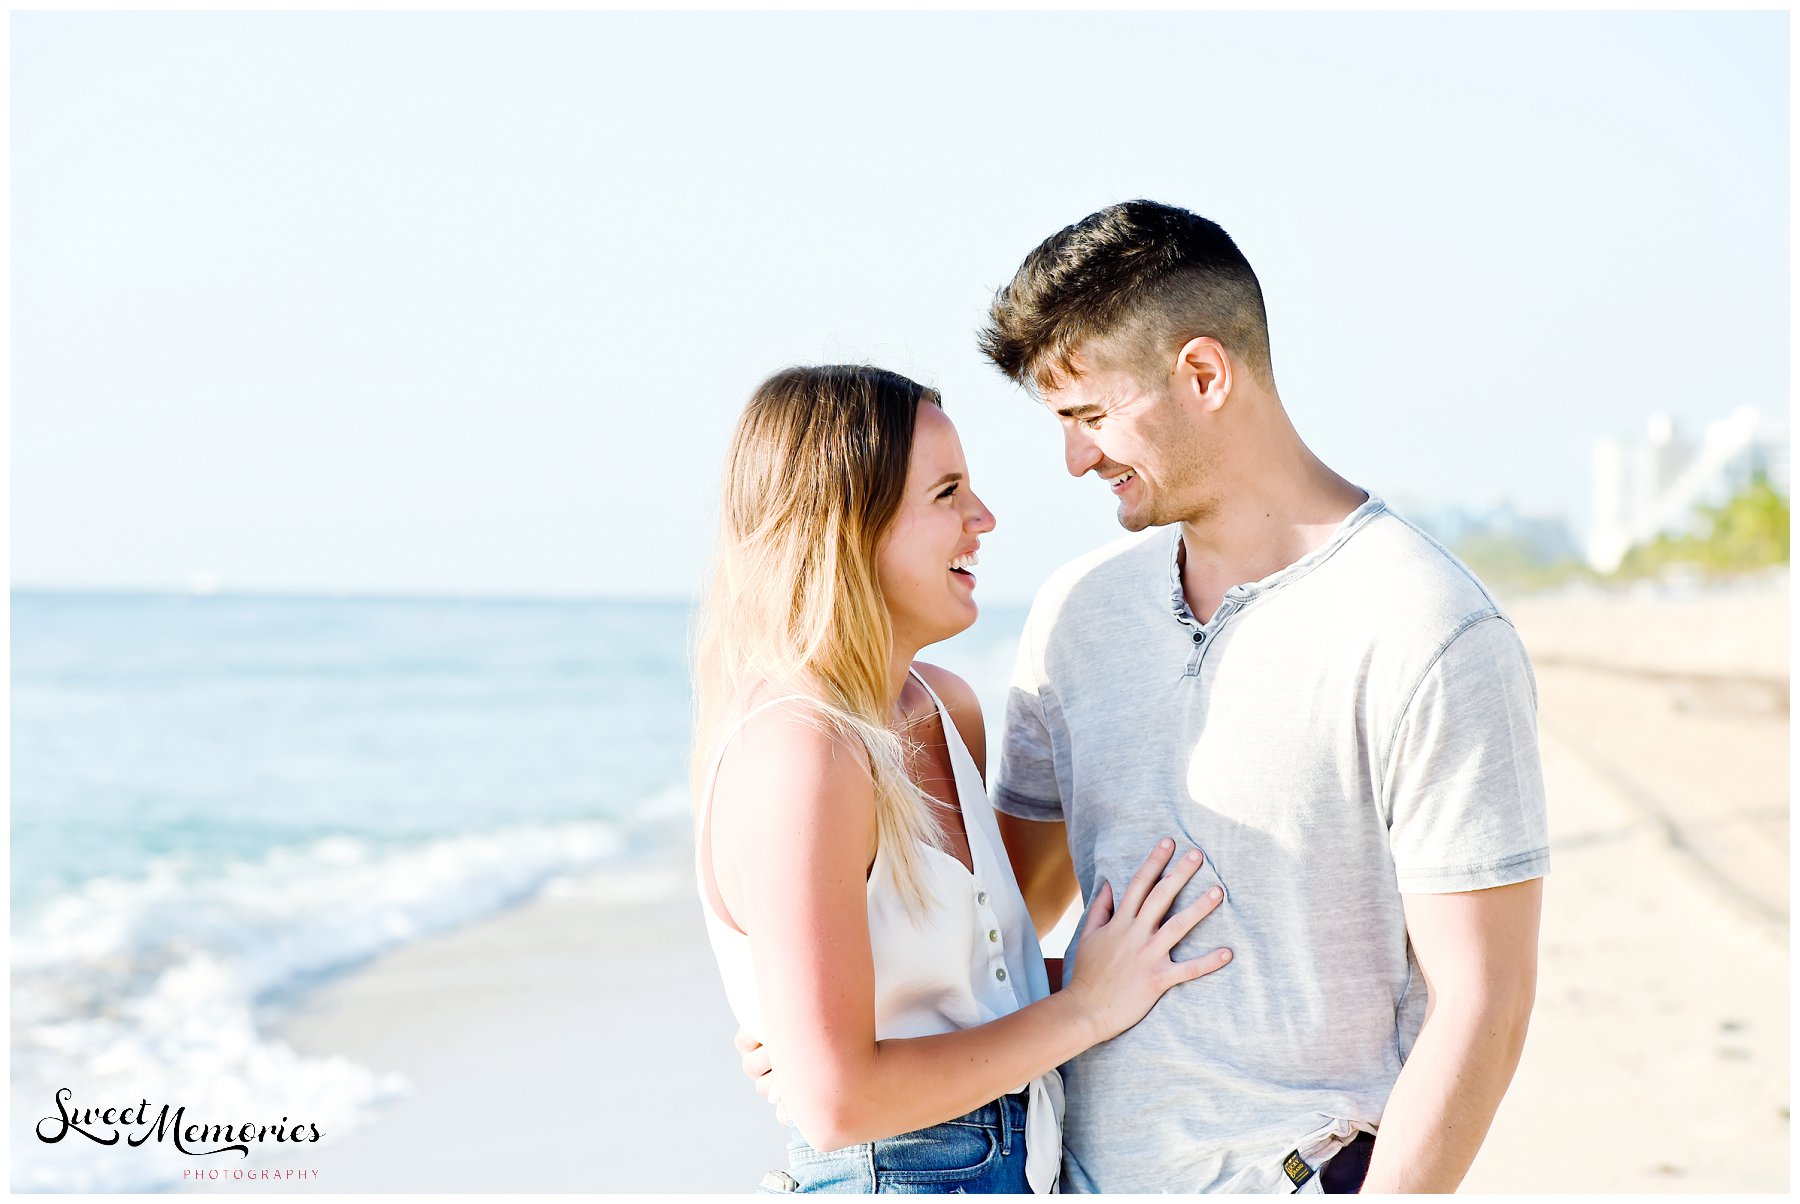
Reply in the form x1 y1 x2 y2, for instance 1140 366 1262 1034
1181 446 1368 623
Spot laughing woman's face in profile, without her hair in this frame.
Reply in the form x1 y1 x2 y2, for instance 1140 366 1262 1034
875 401 994 648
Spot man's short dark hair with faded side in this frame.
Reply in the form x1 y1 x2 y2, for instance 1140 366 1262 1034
981 200 1274 391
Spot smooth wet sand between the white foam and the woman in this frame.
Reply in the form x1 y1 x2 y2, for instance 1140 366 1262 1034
212 867 787 1193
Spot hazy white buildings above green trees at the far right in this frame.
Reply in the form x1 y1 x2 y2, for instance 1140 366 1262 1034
1588 405 1787 572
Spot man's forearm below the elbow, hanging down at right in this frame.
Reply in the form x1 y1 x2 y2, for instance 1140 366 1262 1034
1363 995 1532 1193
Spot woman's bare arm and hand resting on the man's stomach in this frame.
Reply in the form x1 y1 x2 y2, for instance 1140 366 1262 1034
713 707 1229 1148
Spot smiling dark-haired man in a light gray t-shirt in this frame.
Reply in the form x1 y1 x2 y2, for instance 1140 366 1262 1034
981 202 1548 1191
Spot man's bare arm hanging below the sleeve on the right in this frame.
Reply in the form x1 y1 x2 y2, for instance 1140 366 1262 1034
1363 878 1544 1193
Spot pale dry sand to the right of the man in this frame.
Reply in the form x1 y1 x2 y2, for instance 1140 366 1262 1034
1463 574 1791 1193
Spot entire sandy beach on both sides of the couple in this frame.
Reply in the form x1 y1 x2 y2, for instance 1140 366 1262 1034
218 580 1789 1193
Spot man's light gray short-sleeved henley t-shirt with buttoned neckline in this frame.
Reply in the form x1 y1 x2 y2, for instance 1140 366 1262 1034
994 497 1550 1191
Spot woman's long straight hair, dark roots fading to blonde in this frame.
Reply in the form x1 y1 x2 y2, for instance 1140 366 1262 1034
689 364 941 916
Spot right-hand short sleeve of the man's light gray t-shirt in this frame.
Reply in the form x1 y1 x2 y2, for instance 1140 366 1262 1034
1384 614 1550 894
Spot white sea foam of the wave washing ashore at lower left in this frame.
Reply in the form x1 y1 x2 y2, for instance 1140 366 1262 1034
13 806 655 1191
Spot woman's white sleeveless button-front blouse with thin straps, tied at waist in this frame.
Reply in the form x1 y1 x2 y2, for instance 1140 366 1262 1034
695 671 1062 1193
